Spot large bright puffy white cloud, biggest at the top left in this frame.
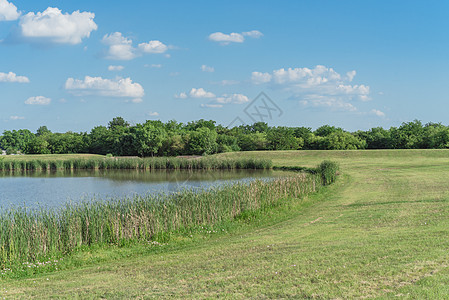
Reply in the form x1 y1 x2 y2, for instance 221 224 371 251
19 7 98 45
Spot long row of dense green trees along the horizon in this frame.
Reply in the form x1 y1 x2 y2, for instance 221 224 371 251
0 117 449 157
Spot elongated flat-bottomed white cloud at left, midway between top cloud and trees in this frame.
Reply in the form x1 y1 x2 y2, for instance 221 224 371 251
65 76 145 103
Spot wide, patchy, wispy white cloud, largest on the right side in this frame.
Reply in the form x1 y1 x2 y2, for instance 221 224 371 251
251 65 371 111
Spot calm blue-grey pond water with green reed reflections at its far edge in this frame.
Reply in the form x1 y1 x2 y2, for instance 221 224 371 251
0 170 285 209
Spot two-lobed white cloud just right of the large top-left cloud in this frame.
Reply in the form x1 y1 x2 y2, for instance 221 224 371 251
102 32 168 60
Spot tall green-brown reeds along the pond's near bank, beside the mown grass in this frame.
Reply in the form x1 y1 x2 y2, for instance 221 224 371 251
0 173 322 268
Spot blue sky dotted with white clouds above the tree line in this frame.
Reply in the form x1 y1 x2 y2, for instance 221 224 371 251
0 0 449 132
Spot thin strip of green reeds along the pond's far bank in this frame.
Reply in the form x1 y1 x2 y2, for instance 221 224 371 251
0 157 272 171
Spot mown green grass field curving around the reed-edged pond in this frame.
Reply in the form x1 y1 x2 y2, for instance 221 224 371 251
0 150 449 299
